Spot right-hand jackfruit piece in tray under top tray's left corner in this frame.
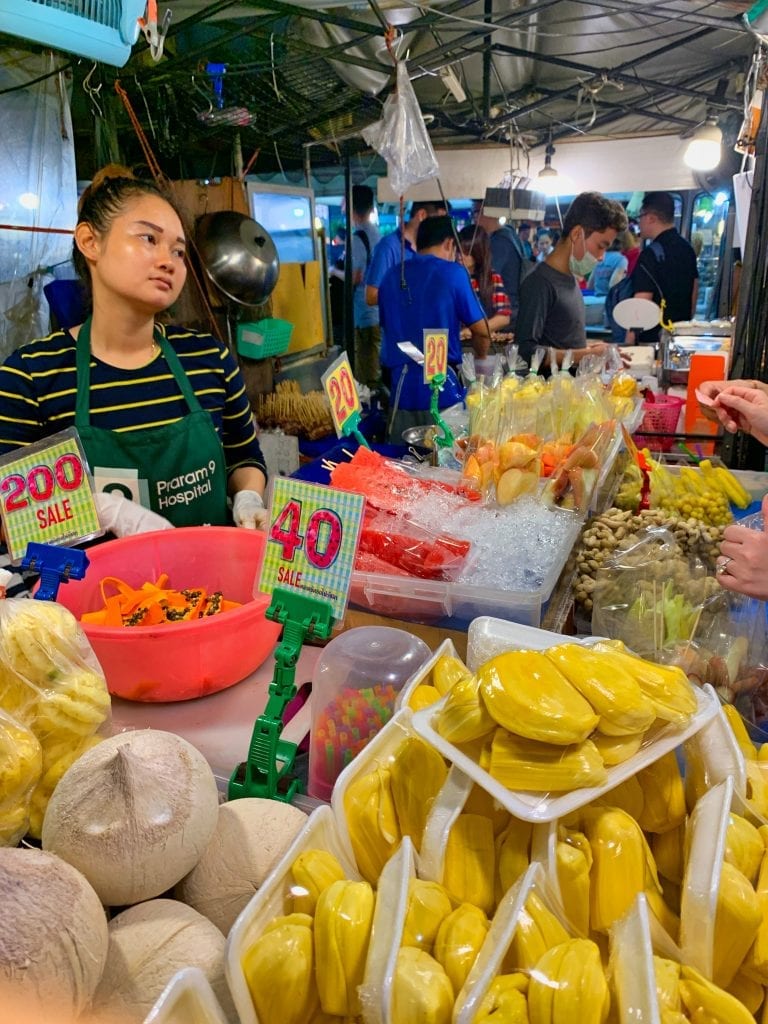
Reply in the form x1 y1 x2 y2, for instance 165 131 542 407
389 736 447 852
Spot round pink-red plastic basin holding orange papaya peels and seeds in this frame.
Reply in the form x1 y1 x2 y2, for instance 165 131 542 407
58 526 281 700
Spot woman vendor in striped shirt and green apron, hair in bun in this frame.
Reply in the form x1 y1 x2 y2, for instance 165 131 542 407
0 165 266 531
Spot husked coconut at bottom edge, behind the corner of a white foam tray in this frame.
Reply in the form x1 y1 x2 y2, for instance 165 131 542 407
93 899 238 1024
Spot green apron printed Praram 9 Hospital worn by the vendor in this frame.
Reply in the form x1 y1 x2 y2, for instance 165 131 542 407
75 317 229 526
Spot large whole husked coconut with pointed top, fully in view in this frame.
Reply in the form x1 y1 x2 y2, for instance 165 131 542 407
43 729 218 906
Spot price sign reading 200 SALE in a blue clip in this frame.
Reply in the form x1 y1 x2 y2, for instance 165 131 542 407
0 427 101 561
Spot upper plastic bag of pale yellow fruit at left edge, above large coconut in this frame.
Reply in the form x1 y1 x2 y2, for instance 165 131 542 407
0 599 111 838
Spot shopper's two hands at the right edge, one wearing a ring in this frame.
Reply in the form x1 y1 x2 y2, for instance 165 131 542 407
702 381 768 601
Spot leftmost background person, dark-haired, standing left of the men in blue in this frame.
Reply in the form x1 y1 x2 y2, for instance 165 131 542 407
331 185 381 387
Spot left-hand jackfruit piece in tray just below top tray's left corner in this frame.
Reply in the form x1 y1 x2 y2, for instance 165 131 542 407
344 768 401 885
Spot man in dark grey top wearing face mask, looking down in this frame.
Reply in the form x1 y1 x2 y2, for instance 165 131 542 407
515 193 627 372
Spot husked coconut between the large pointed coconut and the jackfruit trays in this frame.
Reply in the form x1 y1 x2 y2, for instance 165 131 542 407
176 797 306 935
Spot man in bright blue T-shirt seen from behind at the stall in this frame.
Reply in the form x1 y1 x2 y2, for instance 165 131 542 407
379 216 490 443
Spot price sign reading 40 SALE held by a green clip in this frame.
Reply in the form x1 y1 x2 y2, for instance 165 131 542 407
259 476 366 622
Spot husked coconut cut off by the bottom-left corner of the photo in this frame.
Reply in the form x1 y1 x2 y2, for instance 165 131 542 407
0 848 109 1020
